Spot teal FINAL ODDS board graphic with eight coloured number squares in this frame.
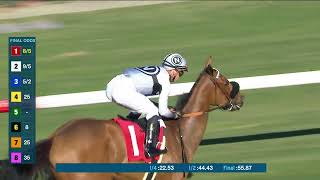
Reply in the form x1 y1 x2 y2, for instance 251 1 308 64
8 37 36 164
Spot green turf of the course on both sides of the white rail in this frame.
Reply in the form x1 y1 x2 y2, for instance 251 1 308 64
0 1 320 179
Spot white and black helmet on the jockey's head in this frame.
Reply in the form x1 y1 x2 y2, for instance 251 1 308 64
162 53 188 71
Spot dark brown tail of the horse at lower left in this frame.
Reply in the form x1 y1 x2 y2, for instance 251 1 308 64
0 139 54 180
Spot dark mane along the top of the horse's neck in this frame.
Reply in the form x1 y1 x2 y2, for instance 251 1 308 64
176 65 213 111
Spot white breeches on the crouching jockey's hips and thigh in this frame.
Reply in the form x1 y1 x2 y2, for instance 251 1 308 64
106 74 159 119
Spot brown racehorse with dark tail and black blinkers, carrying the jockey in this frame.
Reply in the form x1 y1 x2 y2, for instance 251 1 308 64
0 57 243 180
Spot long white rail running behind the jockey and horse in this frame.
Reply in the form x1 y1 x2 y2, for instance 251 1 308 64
36 71 320 108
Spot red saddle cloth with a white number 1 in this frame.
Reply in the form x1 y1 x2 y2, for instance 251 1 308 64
113 117 165 163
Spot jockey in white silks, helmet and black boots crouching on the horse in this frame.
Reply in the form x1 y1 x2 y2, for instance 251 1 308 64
106 53 188 157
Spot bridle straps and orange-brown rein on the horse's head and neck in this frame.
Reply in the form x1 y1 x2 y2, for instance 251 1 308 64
181 68 240 117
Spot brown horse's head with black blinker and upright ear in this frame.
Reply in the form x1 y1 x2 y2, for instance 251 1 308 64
203 56 244 111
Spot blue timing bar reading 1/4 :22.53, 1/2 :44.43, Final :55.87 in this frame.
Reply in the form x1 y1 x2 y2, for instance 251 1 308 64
56 163 267 173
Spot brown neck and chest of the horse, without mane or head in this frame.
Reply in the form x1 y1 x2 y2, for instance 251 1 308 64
180 78 212 162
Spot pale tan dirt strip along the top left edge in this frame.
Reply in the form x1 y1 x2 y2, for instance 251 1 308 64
0 1 179 20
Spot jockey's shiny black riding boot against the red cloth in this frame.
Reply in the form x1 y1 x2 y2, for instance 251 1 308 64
144 116 166 158
